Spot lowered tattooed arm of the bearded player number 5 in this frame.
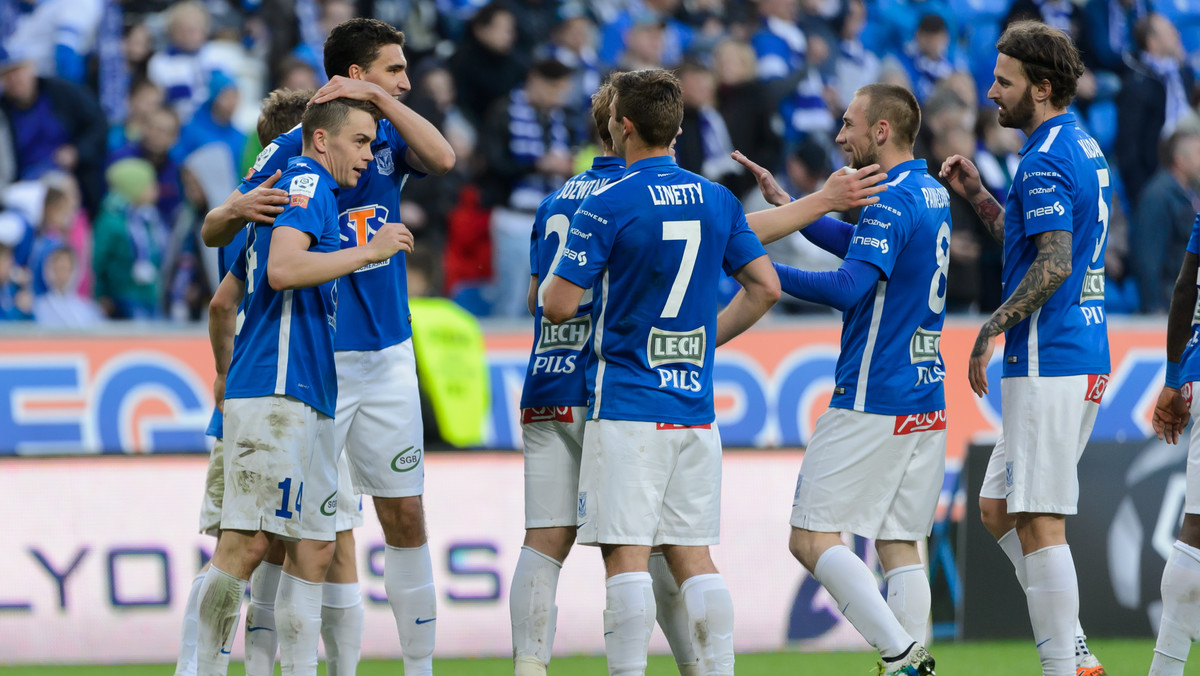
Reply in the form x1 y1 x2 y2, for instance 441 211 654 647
967 231 1072 396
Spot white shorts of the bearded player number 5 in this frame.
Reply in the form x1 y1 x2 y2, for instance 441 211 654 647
979 375 1109 514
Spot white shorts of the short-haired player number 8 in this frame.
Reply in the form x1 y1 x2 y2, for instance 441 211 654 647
791 408 946 542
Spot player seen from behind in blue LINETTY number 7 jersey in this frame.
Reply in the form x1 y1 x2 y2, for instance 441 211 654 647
542 68 780 675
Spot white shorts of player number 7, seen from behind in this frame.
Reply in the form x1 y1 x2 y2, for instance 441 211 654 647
576 420 721 546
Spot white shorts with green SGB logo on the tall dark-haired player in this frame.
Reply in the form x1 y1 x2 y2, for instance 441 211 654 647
334 339 425 497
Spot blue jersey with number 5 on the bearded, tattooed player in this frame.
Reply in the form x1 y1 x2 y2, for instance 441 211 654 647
1003 113 1112 377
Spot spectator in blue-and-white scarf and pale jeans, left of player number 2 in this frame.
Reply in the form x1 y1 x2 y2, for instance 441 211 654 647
480 60 574 317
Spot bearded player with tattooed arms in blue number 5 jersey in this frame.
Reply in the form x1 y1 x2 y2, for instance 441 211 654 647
941 22 1112 676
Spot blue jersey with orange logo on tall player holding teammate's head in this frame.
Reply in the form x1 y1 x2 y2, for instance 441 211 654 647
238 120 424 349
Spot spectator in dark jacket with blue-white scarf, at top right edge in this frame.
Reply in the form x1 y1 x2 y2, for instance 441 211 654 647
1115 12 1198 206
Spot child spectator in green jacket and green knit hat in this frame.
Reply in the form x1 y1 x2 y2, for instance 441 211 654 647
92 157 166 319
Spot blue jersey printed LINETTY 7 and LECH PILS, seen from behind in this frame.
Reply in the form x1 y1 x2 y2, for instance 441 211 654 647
554 156 766 425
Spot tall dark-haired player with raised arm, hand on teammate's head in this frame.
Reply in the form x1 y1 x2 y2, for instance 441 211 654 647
202 18 455 676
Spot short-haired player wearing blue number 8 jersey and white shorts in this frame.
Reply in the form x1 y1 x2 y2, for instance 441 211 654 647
749 84 950 676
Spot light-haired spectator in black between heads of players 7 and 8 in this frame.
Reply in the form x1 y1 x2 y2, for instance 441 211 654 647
713 40 782 200
